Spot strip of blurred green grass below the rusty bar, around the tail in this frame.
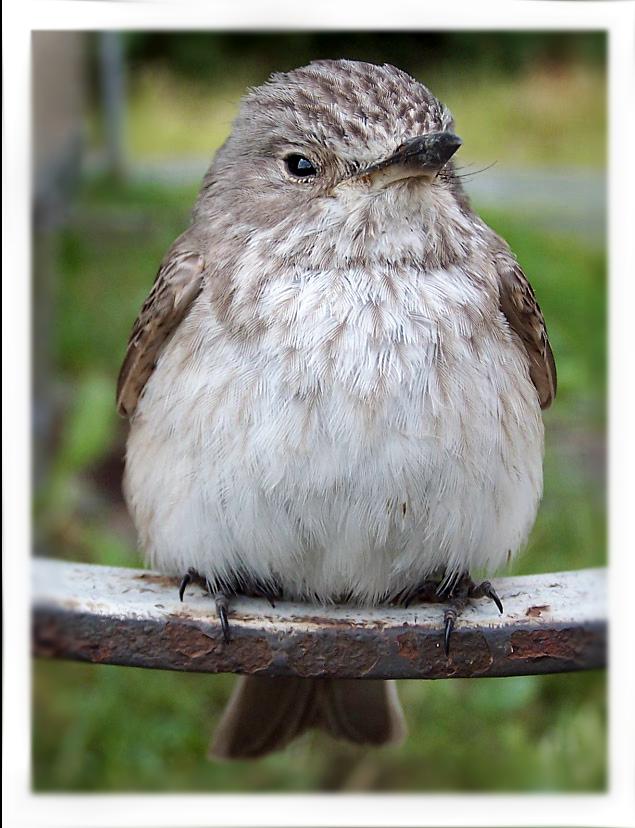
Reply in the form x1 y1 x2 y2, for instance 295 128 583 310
33 662 606 793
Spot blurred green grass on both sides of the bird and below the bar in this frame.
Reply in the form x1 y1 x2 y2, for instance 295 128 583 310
32 173 606 792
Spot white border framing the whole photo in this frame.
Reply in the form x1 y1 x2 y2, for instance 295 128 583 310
2 0 635 828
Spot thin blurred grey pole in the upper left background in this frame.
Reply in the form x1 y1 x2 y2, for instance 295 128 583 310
99 32 126 181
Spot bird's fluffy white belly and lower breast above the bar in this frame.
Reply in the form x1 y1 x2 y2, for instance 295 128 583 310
125 268 542 602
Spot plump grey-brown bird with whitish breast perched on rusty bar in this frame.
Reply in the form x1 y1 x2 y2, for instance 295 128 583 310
117 59 556 759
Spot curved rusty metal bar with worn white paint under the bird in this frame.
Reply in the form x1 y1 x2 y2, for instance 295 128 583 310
33 558 607 679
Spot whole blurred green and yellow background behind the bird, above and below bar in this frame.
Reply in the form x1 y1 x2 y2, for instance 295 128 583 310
33 32 606 792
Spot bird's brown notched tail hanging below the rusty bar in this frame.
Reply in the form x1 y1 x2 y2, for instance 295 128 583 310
210 676 406 759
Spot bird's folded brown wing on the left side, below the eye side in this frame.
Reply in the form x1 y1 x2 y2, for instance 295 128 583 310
117 246 204 417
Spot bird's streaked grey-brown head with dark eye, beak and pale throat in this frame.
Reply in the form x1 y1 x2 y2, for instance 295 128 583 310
198 60 470 260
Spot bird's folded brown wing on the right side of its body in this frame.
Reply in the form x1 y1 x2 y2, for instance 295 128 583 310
496 256 556 408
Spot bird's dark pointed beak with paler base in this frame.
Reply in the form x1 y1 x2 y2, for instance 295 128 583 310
359 132 463 187
